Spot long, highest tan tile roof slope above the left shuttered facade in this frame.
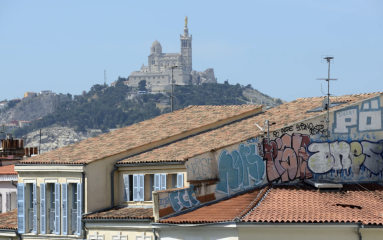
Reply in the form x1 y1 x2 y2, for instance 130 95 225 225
19 105 261 164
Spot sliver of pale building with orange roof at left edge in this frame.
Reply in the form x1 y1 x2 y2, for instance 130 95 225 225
0 165 17 213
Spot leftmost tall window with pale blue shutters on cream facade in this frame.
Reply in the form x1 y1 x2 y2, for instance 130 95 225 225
17 183 37 234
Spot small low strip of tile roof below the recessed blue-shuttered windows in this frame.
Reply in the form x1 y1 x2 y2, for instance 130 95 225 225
83 206 154 219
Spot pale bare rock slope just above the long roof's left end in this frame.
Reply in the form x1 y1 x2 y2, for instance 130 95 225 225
22 127 91 153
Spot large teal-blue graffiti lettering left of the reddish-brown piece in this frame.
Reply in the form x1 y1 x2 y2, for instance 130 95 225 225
216 144 265 195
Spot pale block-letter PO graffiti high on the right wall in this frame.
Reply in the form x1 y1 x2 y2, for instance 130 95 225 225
333 97 383 134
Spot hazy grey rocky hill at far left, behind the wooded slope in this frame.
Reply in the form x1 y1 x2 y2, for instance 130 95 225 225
0 94 69 124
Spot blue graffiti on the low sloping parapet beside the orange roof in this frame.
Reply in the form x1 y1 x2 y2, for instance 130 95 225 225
169 188 201 212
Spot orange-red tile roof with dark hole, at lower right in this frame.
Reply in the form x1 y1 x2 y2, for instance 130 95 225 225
242 184 383 225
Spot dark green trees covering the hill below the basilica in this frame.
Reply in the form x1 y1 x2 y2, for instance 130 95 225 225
14 78 274 137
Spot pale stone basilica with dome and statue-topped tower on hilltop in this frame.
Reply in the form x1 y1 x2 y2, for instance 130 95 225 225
129 17 217 91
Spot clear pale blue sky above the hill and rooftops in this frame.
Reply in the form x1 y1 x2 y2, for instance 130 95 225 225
0 0 383 101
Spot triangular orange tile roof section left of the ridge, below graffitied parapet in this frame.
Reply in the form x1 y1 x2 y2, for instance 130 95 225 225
160 186 269 224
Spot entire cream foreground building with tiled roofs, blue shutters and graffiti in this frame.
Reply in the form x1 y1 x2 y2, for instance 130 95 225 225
0 93 383 240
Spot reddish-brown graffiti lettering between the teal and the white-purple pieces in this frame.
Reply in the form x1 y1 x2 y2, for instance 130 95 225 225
263 133 312 182
